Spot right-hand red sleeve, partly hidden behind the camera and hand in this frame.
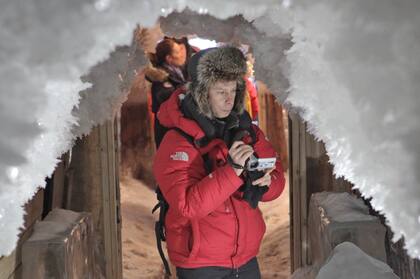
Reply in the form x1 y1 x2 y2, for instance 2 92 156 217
253 125 286 202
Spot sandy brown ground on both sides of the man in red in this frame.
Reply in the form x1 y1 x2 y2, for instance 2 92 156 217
121 174 290 279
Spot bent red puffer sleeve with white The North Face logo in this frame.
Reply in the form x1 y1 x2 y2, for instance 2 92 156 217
153 131 243 219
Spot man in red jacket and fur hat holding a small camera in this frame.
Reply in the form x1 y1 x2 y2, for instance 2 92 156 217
153 47 285 279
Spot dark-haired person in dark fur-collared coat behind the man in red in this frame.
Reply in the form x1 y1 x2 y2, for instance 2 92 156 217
145 37 197 147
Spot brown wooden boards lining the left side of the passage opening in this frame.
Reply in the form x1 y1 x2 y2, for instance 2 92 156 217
67 118 122 279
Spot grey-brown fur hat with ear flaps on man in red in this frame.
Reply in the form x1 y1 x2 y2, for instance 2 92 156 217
188 46 247 119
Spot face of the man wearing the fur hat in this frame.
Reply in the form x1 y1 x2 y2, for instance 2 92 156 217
209 80 236 118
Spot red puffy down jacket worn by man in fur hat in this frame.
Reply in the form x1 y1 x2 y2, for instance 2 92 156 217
153 89 285 268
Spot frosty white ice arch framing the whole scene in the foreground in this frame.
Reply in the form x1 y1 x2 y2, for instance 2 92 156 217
0 0 420 256
